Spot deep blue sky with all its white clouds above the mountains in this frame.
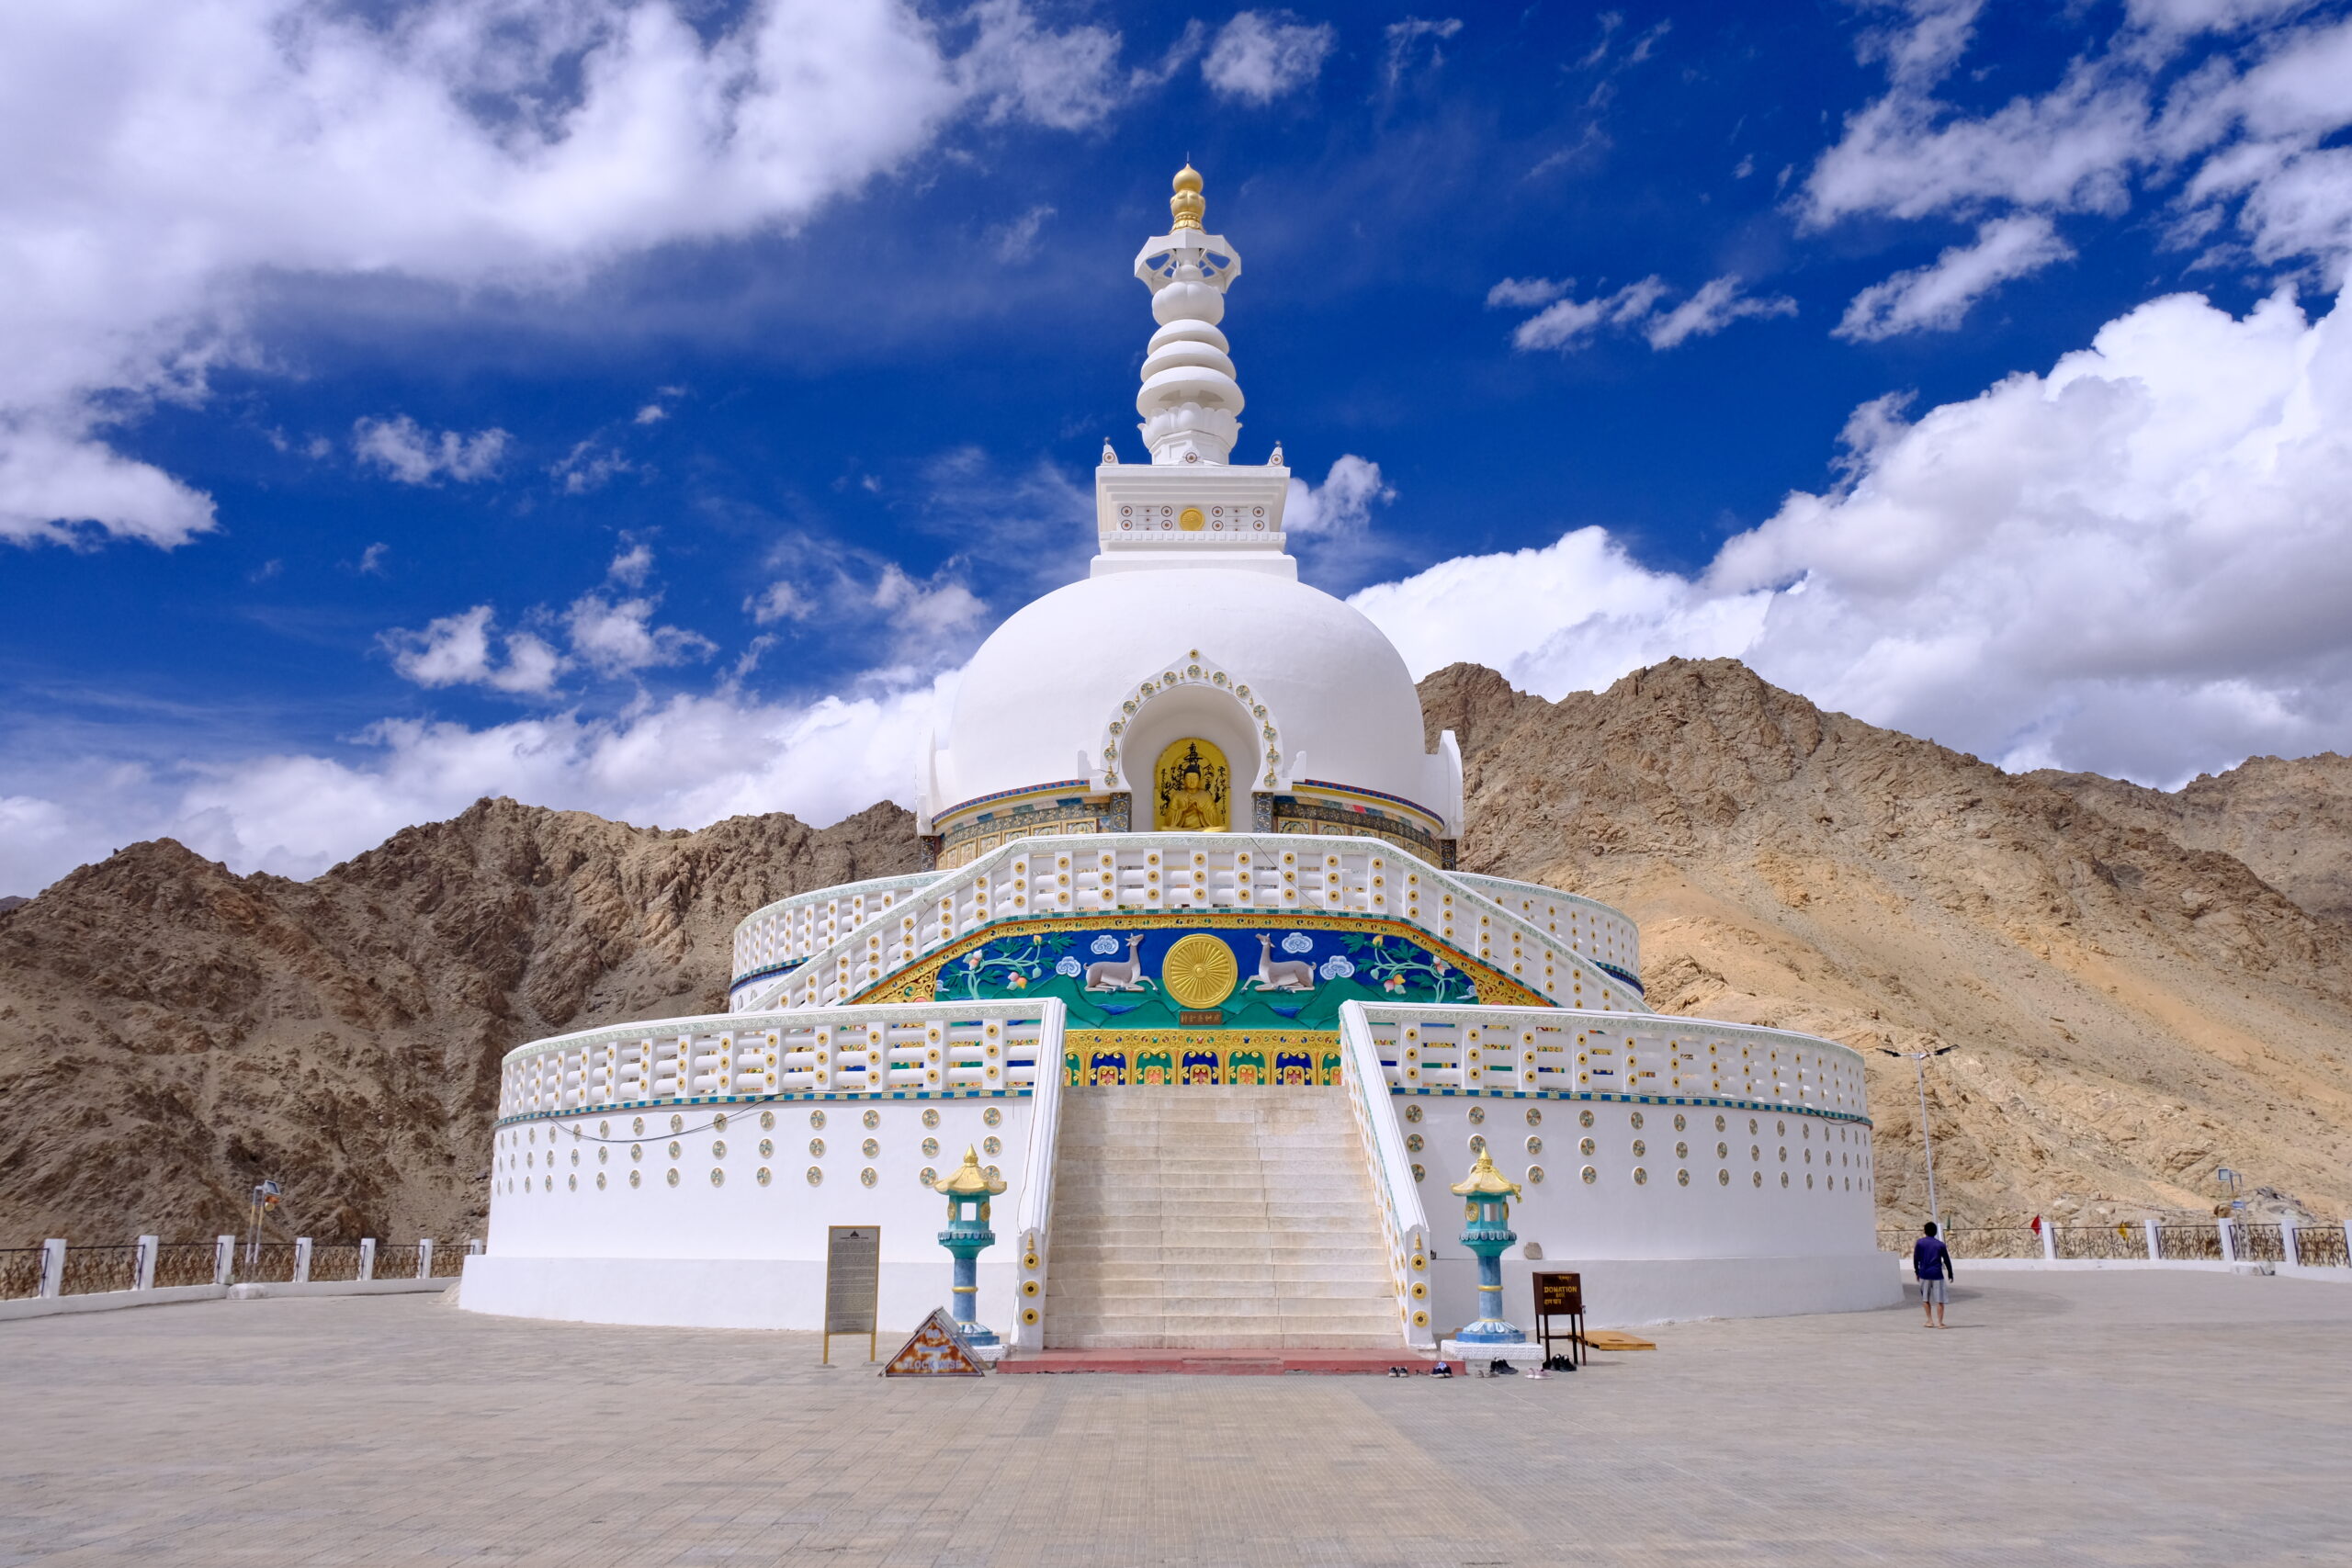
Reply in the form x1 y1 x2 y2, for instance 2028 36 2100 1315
0 0 2352 891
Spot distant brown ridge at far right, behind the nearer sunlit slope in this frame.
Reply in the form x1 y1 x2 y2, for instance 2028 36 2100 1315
2028 752 2352 924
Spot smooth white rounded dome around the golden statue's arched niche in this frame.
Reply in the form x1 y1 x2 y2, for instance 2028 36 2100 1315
929 567 1456 828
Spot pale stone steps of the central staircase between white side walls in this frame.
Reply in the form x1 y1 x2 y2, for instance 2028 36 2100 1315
1045 1086 1404 1352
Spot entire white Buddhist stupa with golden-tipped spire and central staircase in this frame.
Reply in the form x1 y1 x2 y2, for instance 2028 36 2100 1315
461 167 1898 1357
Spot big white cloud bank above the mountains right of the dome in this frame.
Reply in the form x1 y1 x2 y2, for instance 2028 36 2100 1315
1355 294 2352 785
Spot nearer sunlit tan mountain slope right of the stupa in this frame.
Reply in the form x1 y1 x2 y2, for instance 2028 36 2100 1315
1423 660 2352 1223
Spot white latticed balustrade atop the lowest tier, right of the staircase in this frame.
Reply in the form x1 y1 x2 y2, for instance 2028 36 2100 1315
1362 1001 1868 1117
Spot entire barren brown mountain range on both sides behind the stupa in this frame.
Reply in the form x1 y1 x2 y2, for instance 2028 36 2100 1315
0 660 2352 1241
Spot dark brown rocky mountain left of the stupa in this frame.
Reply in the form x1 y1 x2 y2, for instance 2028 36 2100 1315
0 799 917 1244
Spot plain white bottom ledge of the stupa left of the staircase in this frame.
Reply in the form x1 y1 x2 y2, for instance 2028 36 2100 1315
457 1259 1018 1349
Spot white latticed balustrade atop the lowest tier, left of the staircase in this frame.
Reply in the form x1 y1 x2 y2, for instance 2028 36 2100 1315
499 997 1063 1122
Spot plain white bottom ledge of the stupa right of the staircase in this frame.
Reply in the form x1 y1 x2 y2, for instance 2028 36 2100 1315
1430 1248 1905 1337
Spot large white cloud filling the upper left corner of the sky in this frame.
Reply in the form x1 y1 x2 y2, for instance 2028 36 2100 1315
0 0 1117 546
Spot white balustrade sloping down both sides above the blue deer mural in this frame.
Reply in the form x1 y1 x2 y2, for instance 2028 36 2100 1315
734 832 1644 1010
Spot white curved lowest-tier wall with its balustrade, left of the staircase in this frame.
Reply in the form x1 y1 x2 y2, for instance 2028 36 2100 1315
458 999 1063 1337
